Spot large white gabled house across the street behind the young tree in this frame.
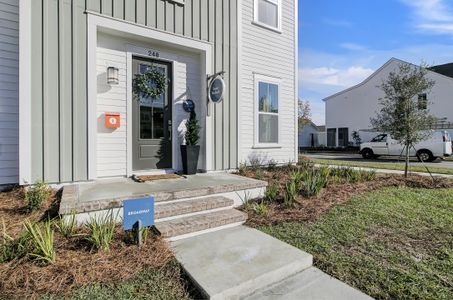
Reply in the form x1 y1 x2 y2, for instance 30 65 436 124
324 58 453 147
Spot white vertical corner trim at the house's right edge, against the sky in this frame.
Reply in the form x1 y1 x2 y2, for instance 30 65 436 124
294 0 299 162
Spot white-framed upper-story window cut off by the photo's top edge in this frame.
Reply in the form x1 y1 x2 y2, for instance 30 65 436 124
255 0 282 31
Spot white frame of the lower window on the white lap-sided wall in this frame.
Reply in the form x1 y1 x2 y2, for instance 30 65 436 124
253 74 282 149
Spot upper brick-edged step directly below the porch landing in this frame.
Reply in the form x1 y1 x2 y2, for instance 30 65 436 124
154 196 234 221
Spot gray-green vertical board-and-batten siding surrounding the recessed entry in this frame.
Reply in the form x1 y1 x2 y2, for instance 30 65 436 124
29 0 238 182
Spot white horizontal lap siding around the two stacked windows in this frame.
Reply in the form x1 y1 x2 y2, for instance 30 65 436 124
239 0 297 163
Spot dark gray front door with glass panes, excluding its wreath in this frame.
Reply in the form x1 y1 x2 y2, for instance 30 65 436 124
132 57 173 171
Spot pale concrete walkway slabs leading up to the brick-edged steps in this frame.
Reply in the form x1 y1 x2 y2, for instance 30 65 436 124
171 226 370 300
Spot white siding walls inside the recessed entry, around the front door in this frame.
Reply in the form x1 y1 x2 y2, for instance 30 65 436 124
96 33 205 178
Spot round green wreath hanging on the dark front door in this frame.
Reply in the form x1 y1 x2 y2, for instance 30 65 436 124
133 67 168 98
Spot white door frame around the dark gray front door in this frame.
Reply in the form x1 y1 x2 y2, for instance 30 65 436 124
126 45 177 177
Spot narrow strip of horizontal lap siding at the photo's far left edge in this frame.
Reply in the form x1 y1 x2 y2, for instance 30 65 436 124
0 0 19 185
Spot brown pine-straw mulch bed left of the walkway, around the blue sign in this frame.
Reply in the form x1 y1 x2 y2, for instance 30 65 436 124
0 188 173 298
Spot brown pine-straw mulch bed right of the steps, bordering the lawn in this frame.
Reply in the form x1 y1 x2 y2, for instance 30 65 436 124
237 167 453 227
